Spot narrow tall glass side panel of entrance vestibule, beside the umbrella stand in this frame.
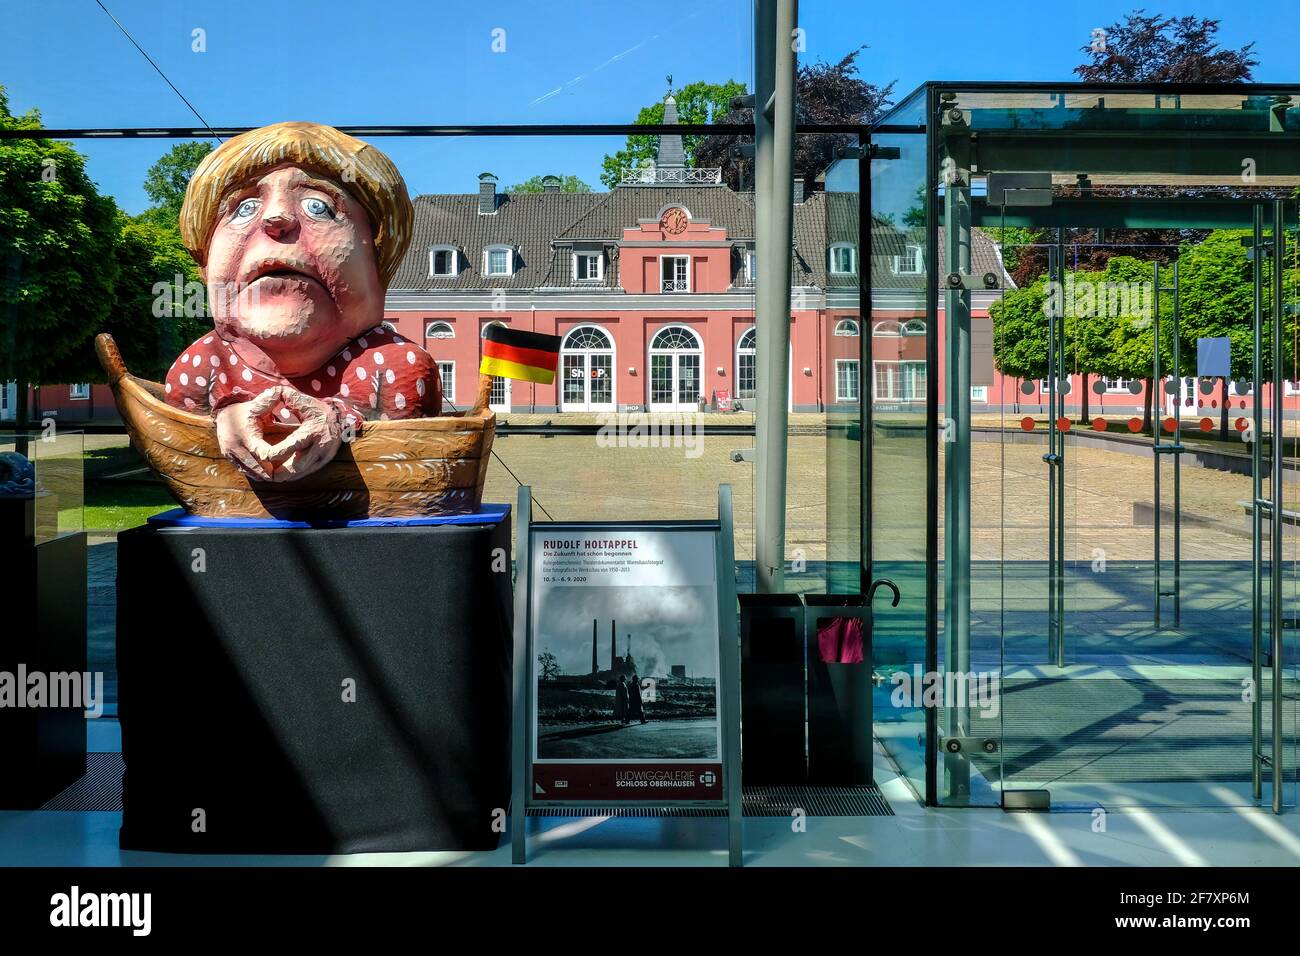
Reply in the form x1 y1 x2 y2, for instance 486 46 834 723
862 82 939 796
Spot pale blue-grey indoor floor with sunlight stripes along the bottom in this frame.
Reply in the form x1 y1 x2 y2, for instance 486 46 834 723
0 721 1300 866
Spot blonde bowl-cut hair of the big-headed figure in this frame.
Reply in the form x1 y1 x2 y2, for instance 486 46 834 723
181 122 415 289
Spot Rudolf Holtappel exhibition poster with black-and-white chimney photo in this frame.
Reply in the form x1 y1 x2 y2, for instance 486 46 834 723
529 524 723 803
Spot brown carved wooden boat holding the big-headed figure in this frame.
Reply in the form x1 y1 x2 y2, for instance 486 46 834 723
95 334 497 520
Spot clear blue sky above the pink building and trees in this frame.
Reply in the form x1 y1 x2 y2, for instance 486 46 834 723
0 0 1300 212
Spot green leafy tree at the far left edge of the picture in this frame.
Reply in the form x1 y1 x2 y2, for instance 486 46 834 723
0 87 118 427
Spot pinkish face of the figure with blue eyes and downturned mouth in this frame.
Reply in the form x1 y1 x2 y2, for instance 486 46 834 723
205 166 384 376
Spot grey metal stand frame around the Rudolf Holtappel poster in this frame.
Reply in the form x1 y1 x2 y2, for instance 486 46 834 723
510 485 744 866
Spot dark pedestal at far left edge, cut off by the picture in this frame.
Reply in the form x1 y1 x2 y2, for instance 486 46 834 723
0 498 86 810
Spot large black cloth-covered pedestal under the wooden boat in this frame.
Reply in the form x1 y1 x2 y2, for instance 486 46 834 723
117 518 511 853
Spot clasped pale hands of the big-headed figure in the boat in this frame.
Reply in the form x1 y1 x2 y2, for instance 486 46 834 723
217 385 343 481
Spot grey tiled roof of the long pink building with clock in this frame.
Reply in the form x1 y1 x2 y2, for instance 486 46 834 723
393 185 1009 291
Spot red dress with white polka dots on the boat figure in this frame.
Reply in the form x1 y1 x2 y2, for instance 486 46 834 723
163 325 442 429
